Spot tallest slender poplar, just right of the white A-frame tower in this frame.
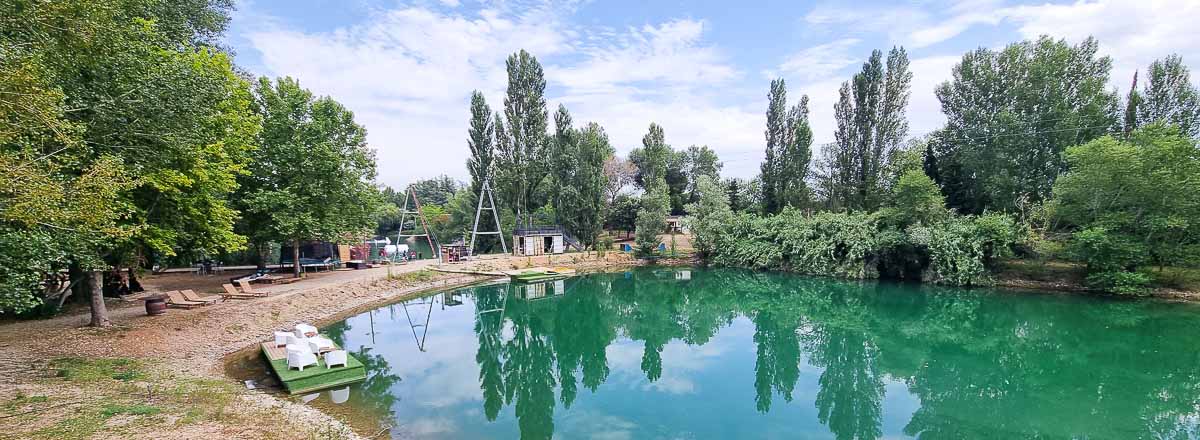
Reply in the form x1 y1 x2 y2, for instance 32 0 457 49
496 49 550 224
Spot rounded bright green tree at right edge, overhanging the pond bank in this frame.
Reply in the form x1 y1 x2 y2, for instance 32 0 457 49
1051 125 1200 293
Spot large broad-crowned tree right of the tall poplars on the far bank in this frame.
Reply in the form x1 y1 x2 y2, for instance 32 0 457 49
935 37 1118 213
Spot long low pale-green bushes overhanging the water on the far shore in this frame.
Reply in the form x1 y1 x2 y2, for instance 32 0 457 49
701 210 1020 287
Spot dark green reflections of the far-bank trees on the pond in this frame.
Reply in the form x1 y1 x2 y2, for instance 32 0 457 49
398 270 1200 439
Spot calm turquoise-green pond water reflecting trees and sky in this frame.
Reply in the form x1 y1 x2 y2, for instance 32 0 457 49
295 269 1200 439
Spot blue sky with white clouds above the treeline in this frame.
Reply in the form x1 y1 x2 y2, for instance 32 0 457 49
224 0 1200 187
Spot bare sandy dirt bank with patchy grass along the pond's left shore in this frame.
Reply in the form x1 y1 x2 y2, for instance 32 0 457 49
0 252 636 439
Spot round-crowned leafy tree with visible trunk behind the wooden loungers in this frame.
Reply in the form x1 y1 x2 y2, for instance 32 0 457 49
241 77 383 277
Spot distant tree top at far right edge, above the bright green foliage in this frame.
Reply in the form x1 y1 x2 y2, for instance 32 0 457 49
1130 55 1200 138
